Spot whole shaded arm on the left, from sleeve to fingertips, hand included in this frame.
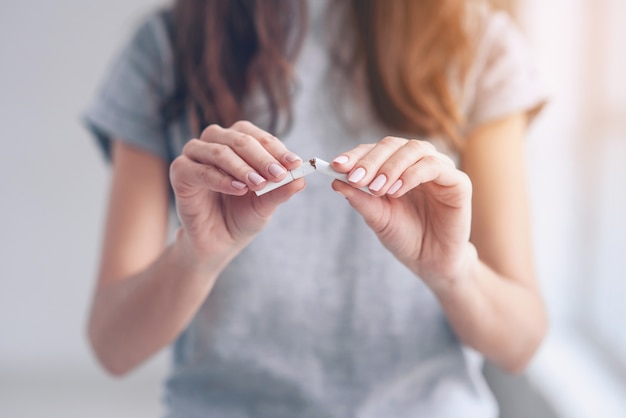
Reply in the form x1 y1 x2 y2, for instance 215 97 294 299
88 123 304 375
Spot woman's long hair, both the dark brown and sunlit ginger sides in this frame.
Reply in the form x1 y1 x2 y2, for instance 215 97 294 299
174 0 482 147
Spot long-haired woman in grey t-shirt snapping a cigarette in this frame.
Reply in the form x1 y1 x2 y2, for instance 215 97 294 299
86 0 546 417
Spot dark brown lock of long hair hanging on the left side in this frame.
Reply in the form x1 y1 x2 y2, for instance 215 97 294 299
172 0 306 135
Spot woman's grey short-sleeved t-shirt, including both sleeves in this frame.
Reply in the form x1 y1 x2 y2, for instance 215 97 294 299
85 2 544 418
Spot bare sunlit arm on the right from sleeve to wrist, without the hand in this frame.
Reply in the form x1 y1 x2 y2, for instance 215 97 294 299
438 114 547 372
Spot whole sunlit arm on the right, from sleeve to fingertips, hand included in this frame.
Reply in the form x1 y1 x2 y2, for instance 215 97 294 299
333 115 546 372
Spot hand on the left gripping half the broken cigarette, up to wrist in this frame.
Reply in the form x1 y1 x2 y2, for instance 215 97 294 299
170 121 305 259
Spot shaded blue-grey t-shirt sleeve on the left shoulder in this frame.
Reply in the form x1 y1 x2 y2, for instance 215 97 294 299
83 14 173 160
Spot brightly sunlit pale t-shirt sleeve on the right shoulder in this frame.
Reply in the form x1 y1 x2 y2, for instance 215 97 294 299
467 12 548 131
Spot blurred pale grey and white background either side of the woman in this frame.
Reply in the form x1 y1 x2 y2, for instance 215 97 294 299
0 0 626 417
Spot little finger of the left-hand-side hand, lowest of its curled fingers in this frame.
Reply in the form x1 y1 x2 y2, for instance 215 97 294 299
170 155 248 196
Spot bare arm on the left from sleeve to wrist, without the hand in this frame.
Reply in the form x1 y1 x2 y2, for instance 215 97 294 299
88 141 223 375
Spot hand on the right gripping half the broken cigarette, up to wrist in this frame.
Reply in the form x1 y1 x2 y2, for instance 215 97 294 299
332 137 476 287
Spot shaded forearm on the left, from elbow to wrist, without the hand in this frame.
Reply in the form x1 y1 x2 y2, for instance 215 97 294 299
88 230 234 375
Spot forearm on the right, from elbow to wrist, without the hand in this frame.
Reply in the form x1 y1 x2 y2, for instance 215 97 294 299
434 243 547 372
